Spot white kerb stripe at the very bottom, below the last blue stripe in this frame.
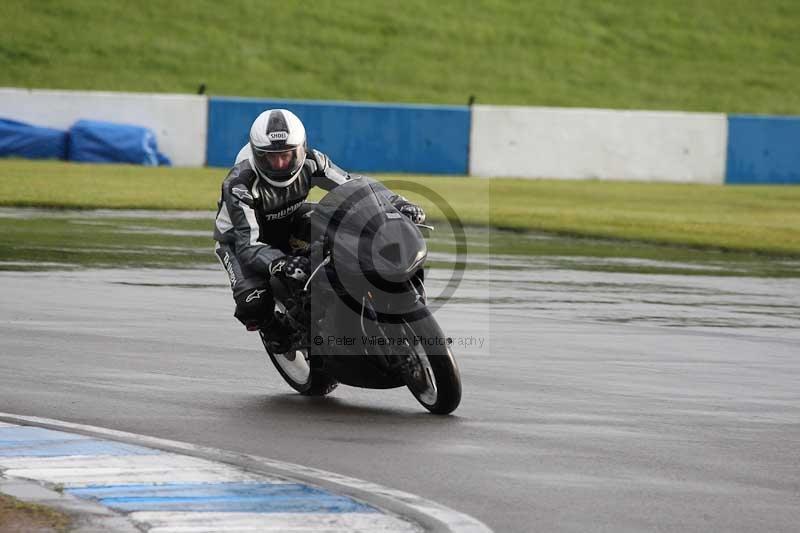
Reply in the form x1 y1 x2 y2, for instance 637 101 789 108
130 512 421 533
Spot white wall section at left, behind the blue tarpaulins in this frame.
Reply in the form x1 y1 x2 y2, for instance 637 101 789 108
0 88 208 167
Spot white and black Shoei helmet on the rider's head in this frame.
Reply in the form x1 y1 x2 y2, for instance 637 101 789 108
250 109 307 187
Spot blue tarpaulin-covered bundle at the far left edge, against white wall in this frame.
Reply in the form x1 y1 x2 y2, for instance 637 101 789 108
0 119 67 159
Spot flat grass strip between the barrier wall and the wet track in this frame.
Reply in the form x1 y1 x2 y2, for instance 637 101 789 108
0 160 800 256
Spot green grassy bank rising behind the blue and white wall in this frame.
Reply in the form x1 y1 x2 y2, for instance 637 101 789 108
0 0 800 114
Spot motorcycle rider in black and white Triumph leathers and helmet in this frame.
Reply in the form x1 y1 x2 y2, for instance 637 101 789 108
214 109 425 353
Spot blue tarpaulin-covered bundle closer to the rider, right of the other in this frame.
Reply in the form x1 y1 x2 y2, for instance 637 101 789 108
69 120 171 166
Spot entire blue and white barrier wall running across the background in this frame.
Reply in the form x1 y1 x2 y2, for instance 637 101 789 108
0 88 800 183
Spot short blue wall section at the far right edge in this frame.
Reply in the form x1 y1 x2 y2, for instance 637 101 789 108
725 115 800 184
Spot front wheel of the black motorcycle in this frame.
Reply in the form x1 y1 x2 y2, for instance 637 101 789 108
396 315 461 415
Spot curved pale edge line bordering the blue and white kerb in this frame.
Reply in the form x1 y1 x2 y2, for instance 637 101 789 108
0 412 491 533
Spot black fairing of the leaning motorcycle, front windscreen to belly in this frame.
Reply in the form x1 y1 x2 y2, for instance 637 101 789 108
276 177 438 389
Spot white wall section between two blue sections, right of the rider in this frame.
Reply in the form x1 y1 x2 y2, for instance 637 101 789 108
470 105 728 183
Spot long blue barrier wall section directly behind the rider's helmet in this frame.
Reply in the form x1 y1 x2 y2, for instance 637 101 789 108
207 98 470 174
